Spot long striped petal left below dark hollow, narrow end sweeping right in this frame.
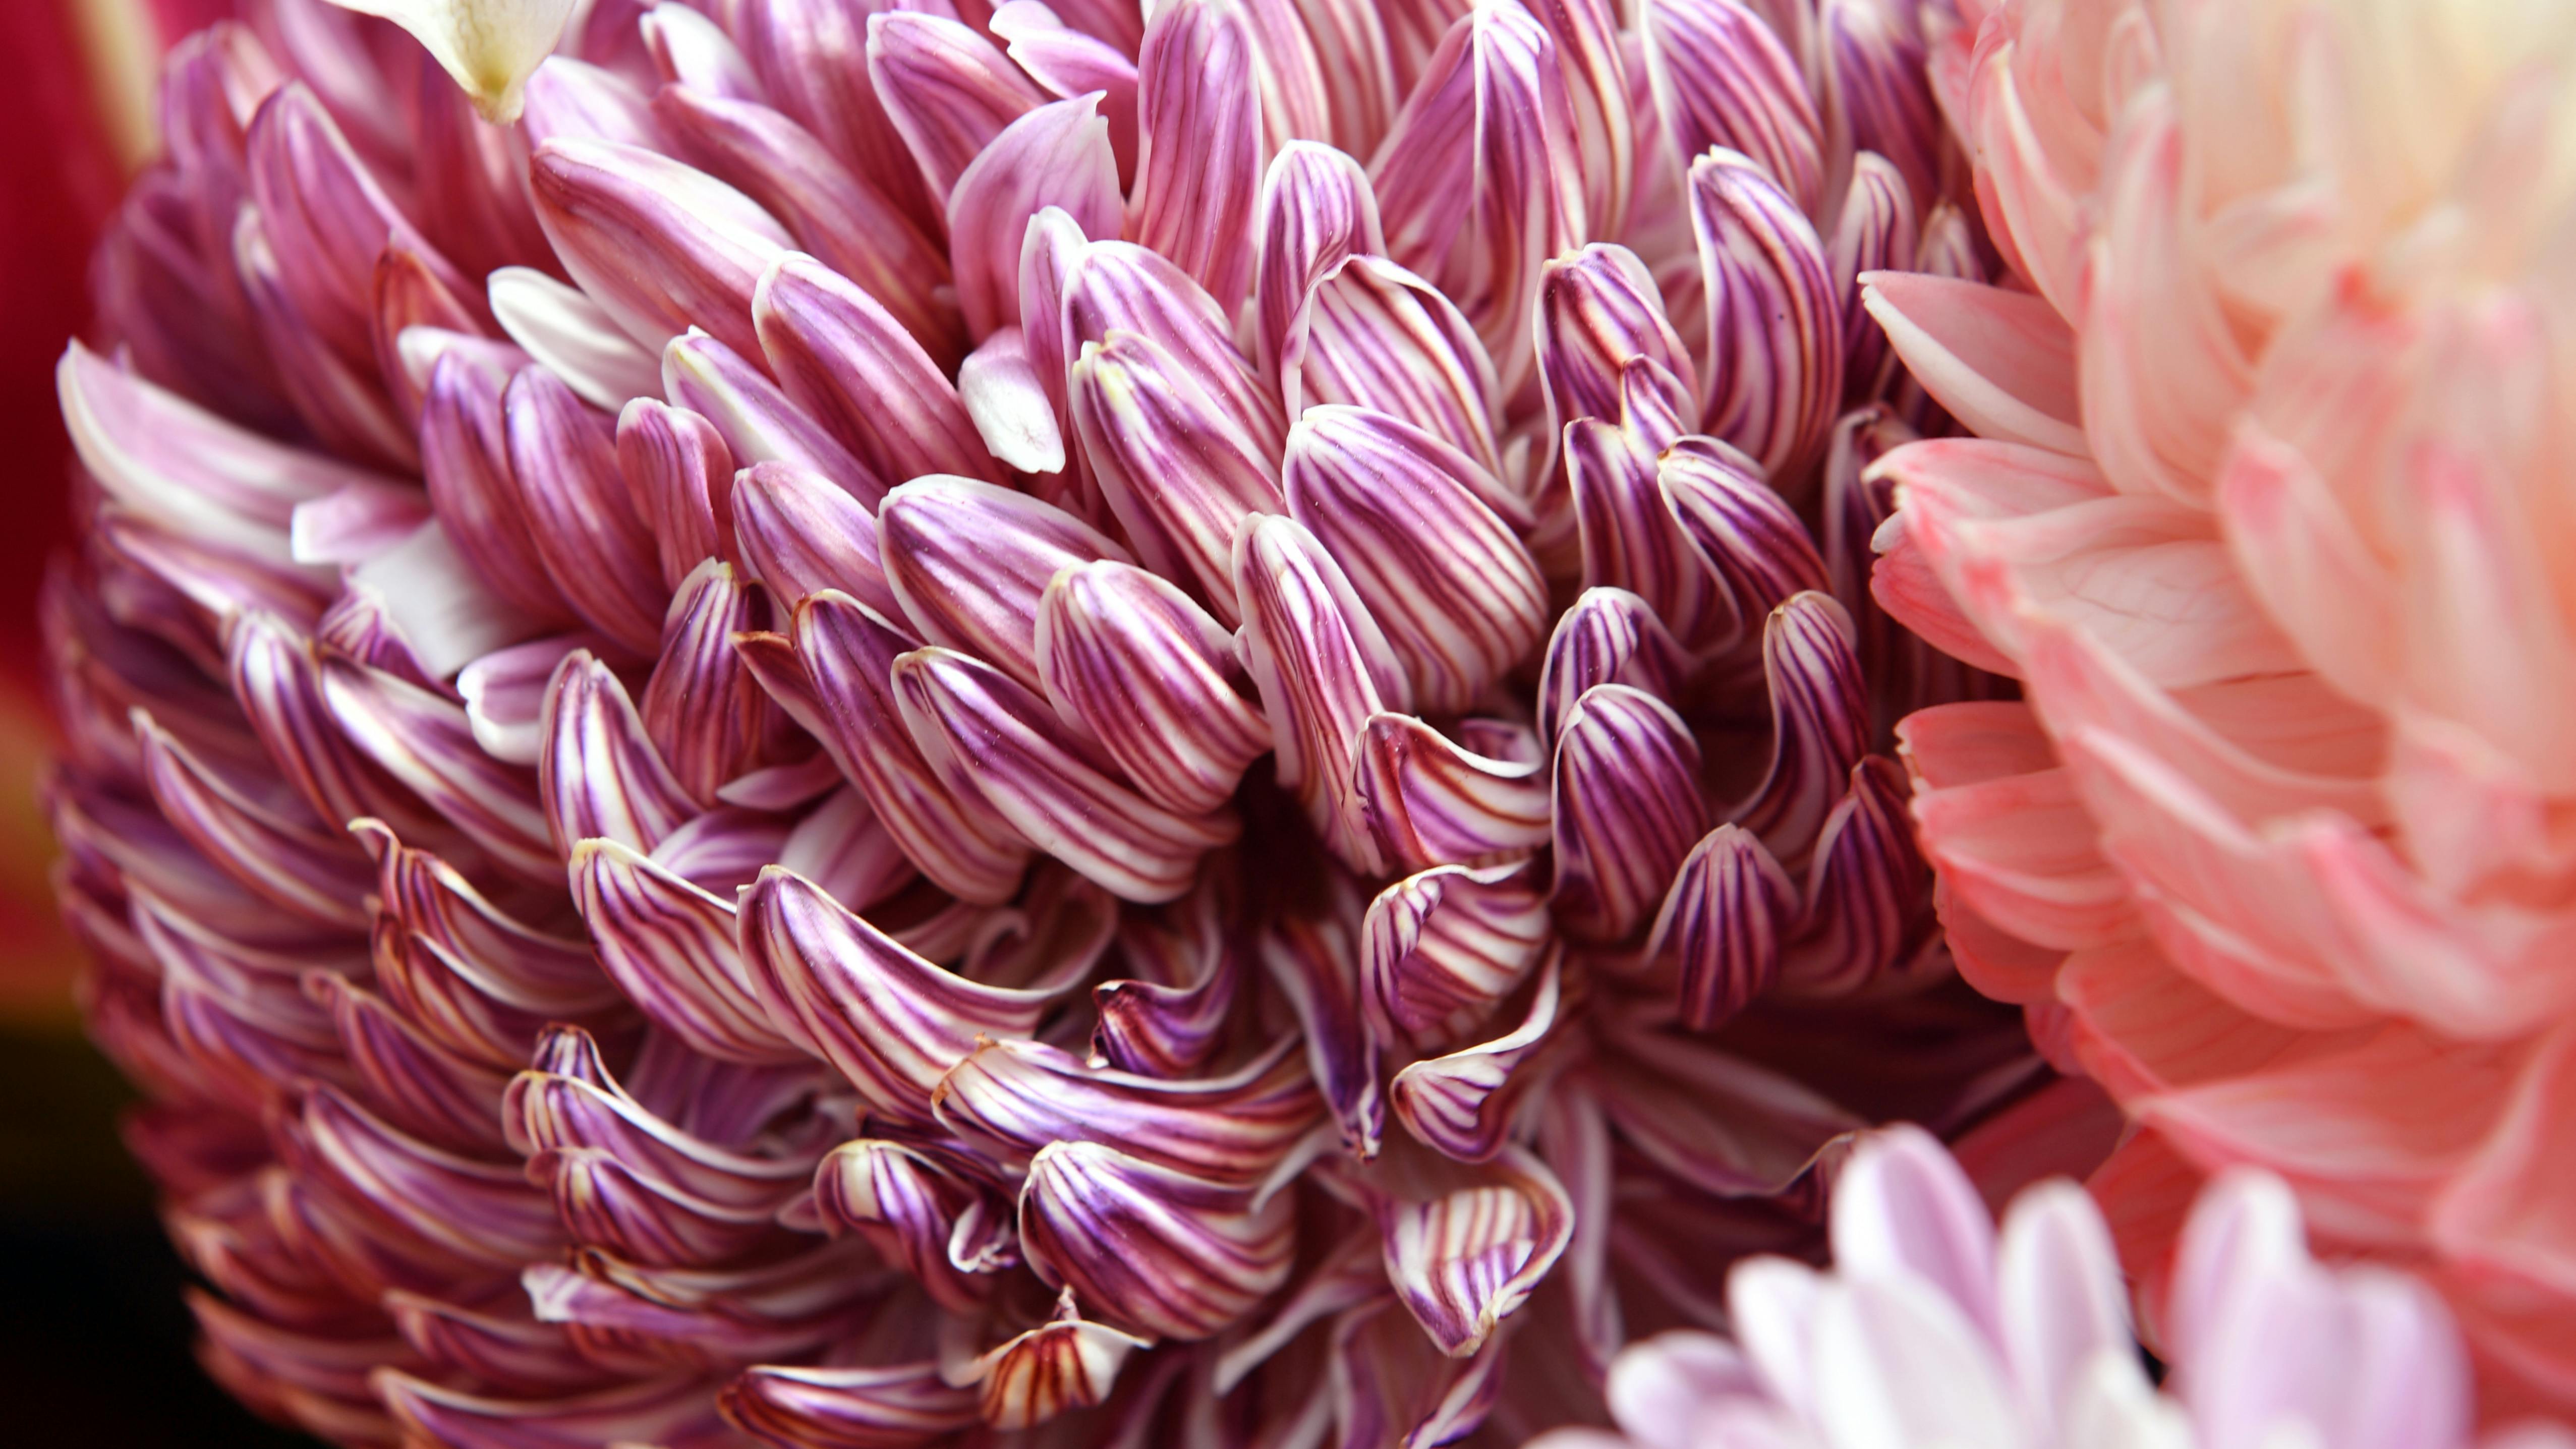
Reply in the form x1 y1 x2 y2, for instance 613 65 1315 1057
739 865 1090 1125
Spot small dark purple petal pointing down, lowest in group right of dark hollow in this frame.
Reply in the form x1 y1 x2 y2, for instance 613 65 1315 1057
1646 824 1798 1032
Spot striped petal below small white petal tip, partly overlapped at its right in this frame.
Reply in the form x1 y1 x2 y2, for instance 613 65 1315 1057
876 476 1133 690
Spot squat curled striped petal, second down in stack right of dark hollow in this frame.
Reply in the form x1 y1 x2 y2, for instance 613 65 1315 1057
1360 865 1554 1048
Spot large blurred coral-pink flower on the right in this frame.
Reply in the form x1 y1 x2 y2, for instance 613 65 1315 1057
1870 0 2576 1410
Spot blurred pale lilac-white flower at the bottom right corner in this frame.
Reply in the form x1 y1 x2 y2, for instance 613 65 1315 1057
1530 1127 2576 1449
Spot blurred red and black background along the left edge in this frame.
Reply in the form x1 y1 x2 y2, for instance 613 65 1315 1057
0 0 312 1449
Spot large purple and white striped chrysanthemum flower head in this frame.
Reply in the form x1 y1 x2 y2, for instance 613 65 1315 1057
49 0 2071 1449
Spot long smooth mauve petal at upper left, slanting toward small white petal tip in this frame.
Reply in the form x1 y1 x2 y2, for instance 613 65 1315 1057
654 85 966 363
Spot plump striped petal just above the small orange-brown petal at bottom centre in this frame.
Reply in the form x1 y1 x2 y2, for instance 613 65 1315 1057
1020 1143 1296 1344
